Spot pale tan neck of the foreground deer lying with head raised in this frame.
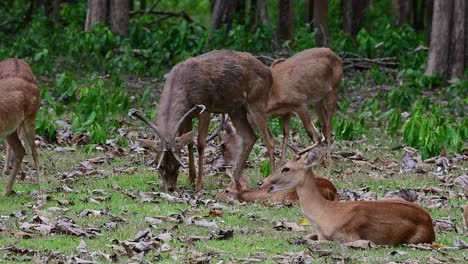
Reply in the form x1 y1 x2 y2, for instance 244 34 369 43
296 170 336 227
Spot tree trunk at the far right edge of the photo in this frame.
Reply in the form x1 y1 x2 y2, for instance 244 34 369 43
448 0 468 78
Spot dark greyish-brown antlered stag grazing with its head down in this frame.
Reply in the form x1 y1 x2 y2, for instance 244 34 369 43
129 50 274 190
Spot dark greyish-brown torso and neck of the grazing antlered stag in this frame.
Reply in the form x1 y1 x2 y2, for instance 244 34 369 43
156 50 272 138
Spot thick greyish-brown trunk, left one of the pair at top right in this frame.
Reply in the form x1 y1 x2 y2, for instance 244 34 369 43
426 0 453 75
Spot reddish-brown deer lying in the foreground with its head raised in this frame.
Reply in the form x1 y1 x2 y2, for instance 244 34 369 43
269 146 435 245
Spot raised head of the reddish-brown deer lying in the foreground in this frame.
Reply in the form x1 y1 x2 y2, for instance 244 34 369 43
262 144 327 193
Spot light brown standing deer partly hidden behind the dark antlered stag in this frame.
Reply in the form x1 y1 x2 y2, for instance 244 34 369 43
268 48 343 165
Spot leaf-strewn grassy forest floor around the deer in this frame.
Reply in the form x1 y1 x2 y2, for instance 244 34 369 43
0 75 468 263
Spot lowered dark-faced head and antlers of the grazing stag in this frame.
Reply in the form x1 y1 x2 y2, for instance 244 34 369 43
128 105 205 191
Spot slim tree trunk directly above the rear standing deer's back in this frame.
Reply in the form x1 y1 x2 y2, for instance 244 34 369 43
314 0 329 47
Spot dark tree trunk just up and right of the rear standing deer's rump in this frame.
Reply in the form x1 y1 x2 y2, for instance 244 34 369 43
341 0 370 36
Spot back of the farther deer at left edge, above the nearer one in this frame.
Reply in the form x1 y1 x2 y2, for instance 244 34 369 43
0 58 37 85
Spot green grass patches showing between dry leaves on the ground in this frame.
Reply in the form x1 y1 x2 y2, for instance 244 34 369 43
0 137 467 263
